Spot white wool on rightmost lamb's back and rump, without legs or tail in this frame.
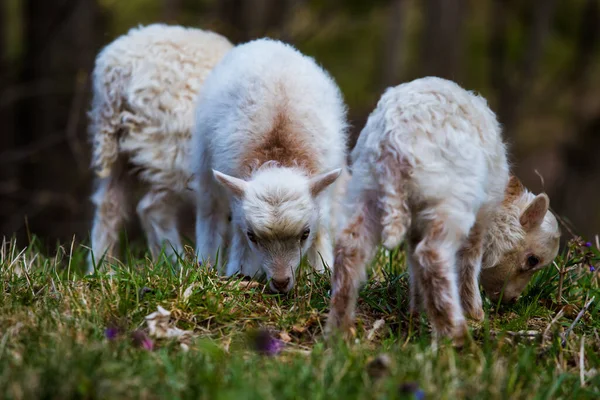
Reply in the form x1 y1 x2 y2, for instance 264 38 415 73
351 77 508 228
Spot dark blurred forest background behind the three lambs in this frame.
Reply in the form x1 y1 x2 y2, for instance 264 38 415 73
0 0 600 246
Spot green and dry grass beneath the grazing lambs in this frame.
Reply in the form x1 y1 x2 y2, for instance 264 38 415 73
0 236 600 399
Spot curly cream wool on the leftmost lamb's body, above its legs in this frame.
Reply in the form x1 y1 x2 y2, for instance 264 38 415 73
89 24 232 190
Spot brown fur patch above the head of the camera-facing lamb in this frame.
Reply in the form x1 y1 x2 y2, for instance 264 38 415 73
242 111 319 175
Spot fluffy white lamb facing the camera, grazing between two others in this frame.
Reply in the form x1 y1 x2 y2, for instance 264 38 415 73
194 39 346 292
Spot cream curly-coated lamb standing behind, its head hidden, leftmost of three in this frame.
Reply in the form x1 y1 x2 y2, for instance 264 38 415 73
88 24 232 272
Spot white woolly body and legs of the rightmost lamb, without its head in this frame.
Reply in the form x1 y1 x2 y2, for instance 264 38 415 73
329 77 509 338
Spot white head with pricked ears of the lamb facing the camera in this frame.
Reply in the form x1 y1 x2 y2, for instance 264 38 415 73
215 167 340 293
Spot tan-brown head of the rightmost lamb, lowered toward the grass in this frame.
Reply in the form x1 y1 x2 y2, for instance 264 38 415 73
481 177 560 303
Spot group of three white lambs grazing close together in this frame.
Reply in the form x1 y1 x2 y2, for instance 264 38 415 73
84 24 560 342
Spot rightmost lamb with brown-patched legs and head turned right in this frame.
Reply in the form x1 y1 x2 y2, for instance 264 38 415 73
326 77 560 344
